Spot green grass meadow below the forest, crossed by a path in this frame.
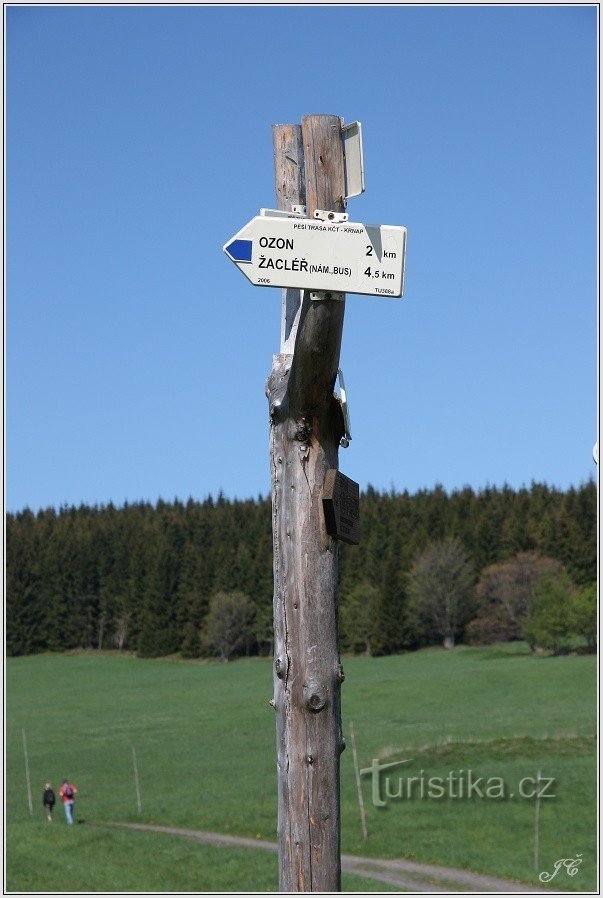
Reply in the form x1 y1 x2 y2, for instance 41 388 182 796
7 644 596 891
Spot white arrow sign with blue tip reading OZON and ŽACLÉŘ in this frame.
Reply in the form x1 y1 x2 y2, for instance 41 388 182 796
224 215 406 297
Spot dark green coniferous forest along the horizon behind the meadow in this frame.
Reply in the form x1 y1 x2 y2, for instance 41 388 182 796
6 480 597 658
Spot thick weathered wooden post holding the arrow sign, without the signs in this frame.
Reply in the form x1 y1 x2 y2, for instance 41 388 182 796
266 115 345 892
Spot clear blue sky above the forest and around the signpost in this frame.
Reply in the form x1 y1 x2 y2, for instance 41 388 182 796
7 6 597 510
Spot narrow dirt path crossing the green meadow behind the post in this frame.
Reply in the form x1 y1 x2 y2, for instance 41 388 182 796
106 823 547 894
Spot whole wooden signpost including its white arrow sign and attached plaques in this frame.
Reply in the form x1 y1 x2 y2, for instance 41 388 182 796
224 115 406 892
